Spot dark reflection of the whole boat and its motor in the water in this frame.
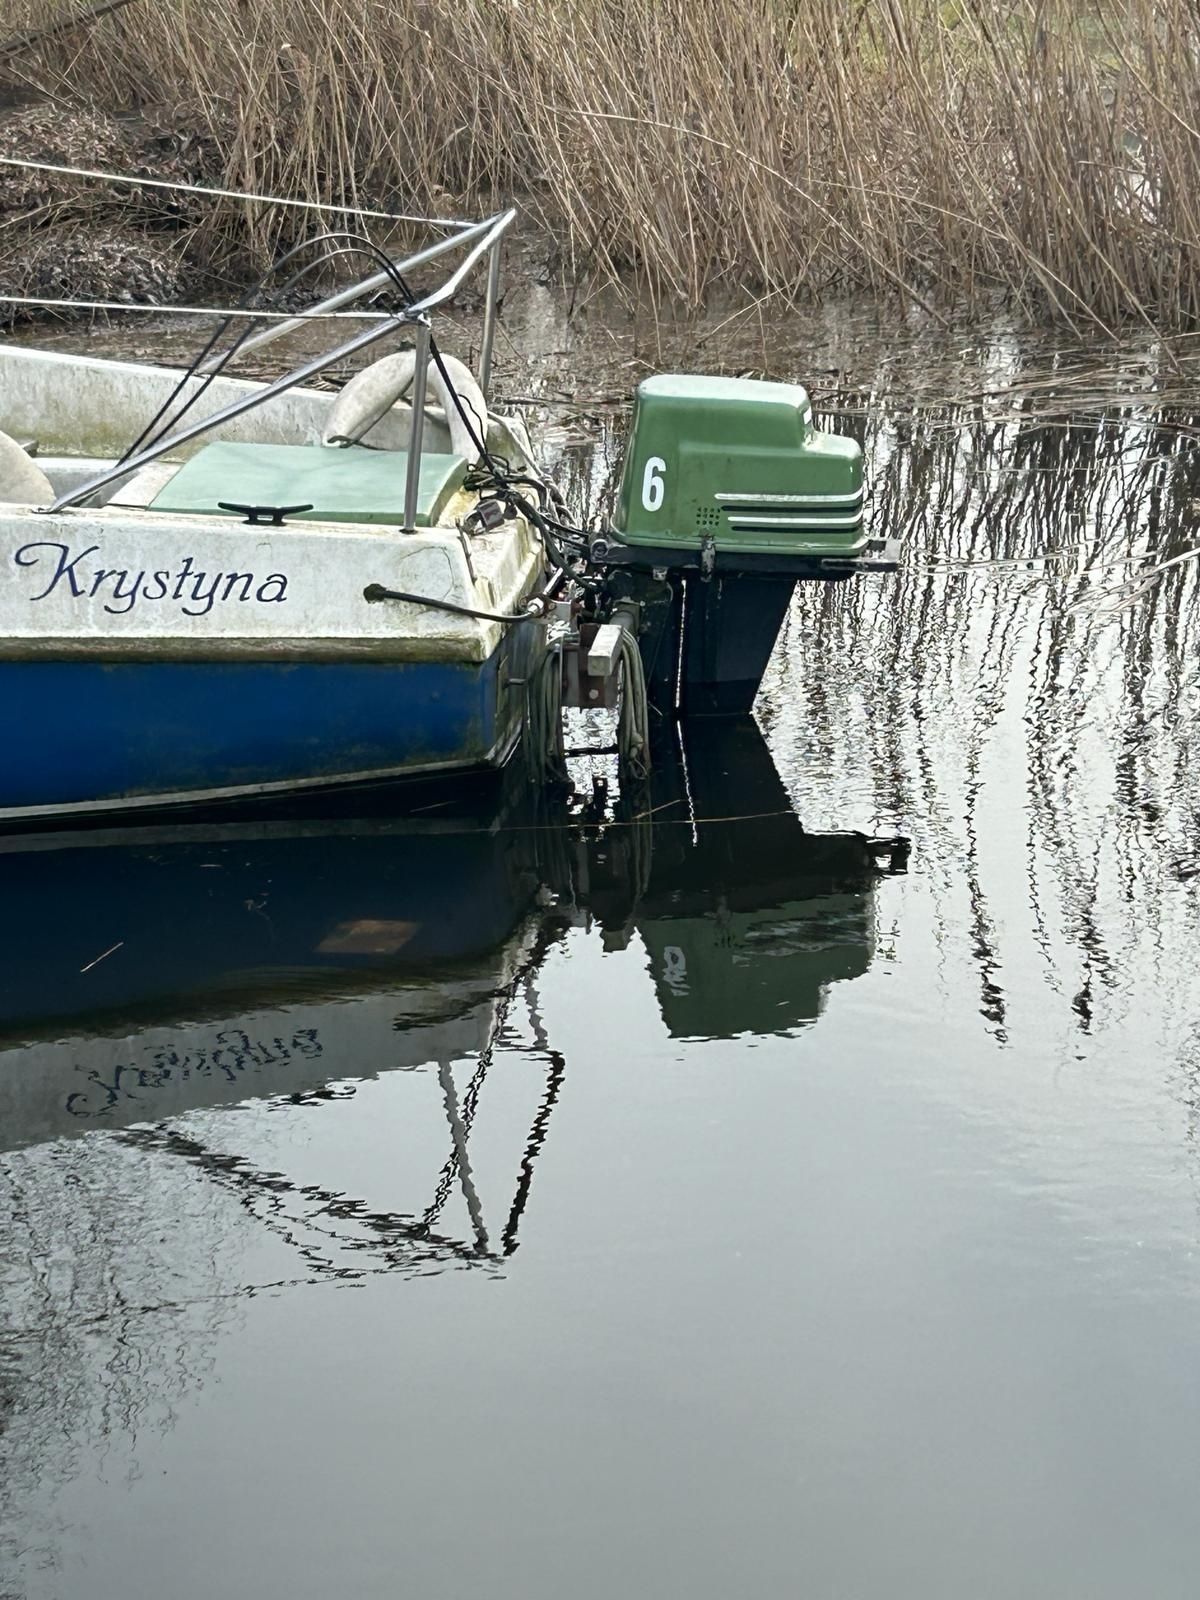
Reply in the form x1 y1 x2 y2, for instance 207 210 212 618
0 720 907 1250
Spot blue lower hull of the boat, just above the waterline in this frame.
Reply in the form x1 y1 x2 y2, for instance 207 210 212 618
0 640 522 824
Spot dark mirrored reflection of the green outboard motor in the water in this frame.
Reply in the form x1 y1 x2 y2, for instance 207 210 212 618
576 718 909 1038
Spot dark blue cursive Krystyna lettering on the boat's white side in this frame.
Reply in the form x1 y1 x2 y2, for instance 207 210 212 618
13 539 288 616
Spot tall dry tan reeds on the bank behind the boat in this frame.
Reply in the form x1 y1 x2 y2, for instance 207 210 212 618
3 0 1200 330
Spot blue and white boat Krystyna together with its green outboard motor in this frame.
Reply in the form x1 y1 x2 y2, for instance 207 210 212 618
0 193 898 829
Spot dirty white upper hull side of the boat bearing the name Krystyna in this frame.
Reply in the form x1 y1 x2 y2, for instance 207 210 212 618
0 507 544 662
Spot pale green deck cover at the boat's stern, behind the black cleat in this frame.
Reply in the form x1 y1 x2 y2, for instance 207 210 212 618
150 443 467 528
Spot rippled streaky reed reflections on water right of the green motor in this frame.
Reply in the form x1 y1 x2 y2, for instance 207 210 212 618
784 368 1200 1040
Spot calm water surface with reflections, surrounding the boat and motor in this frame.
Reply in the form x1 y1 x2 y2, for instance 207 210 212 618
0 298 1200 1600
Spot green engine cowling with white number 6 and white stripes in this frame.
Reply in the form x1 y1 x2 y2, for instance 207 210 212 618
613 376 869 573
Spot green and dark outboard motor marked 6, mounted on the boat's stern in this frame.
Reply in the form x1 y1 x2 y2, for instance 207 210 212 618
592 376 899 717
